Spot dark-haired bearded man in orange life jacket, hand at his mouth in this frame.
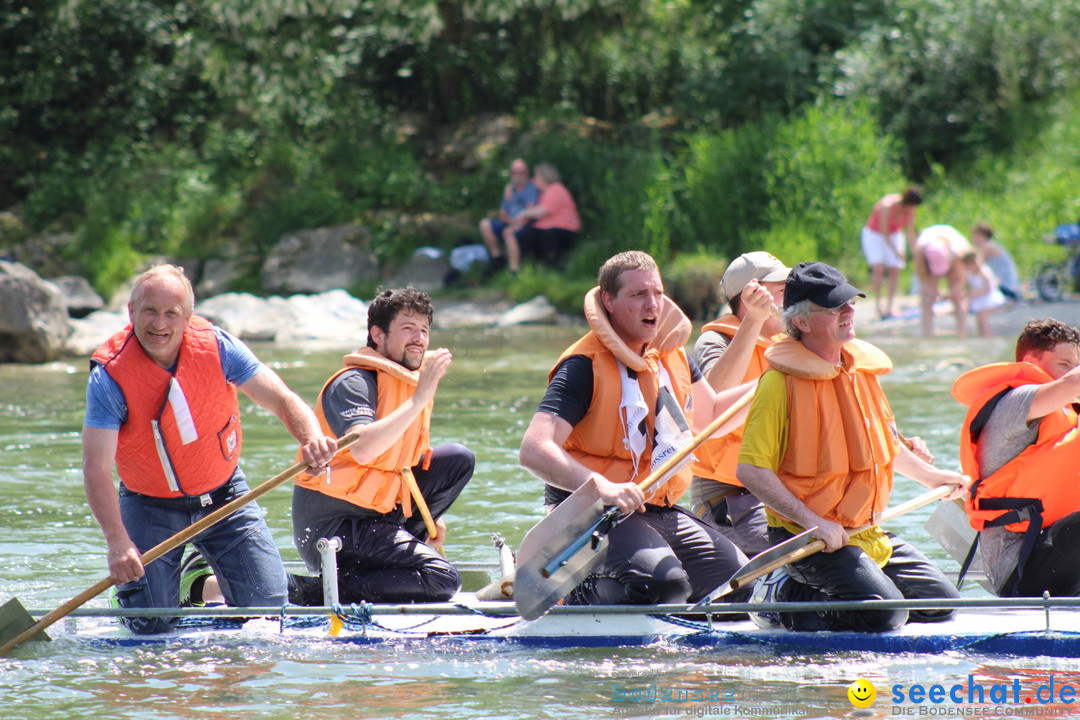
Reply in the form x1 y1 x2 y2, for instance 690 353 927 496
293 286 475 604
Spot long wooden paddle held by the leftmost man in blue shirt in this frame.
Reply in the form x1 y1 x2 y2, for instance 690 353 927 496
0 433 357 657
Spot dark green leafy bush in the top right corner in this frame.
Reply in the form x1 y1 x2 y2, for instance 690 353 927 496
838 0 1080 176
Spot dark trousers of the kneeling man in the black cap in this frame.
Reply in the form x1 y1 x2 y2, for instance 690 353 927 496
769 528 960 633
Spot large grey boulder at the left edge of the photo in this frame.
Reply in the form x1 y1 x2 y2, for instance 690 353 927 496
0 260 70 363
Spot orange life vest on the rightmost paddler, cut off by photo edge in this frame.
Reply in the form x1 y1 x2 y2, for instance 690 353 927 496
953 363 1080 532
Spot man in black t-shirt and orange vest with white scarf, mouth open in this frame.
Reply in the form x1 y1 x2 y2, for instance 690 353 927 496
521 252 748 604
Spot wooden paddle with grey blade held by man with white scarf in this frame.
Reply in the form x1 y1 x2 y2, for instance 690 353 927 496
514 385 756 620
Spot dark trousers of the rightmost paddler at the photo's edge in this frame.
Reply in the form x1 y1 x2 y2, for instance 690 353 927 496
1005 513 1080 597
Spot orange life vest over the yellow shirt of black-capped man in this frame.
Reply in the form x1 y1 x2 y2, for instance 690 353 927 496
765 338 899 528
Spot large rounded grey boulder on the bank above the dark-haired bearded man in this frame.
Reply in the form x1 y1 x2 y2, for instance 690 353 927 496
262 225 379 295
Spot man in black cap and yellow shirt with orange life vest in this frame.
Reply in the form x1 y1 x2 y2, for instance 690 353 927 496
737 262 970 633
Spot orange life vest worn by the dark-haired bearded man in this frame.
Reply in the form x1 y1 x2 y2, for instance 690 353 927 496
296 348 434 517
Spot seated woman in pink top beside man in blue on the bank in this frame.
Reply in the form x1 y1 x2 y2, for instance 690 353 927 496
502 163 581 272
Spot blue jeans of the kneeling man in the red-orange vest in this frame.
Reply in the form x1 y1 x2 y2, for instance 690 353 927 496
117 476 287 635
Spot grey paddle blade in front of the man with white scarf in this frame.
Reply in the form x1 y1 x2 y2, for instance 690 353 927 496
514 480 608 620
